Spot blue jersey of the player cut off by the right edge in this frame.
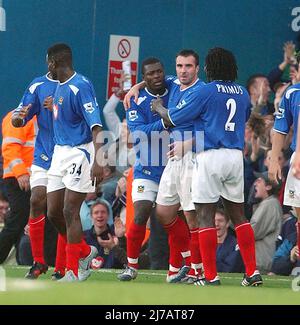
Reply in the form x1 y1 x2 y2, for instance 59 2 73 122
274 83 300 151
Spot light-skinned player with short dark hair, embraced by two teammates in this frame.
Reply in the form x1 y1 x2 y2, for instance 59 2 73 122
125 50 204 283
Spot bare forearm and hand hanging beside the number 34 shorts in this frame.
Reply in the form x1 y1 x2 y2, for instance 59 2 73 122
91 125 104 184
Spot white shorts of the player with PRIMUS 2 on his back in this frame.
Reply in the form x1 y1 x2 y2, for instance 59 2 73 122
192 148 244 203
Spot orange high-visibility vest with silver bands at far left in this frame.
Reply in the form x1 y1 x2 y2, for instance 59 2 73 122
2 111 38 178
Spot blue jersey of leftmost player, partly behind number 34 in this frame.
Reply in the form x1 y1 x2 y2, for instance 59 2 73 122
16 75 58 170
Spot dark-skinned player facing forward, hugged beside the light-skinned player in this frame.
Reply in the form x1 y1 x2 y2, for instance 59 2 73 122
118 58 169 281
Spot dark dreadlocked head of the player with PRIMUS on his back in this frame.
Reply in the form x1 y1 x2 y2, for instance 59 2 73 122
204 47 238 81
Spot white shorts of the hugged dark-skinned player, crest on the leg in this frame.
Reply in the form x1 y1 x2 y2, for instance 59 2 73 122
131 178 158 202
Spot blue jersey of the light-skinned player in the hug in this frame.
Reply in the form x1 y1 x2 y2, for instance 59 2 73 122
167 78 205 141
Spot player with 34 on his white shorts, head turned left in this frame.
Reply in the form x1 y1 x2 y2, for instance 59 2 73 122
47 44 104 282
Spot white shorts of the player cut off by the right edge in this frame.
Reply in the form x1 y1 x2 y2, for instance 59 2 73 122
283 153 300 208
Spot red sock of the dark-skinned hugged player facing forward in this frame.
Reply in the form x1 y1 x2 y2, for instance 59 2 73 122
127 221 146 269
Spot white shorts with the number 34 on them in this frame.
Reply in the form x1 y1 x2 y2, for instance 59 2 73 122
47 142 95 193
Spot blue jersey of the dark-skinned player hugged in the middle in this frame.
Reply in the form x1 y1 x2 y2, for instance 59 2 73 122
126 88 169 183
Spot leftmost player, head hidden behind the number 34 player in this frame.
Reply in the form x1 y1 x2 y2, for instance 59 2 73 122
12 73 65 279
